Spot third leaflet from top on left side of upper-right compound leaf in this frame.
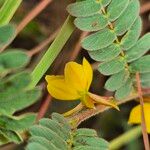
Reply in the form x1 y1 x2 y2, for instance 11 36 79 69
82 29 116 51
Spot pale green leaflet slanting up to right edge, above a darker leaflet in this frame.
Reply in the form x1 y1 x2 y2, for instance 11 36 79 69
126 33 150 62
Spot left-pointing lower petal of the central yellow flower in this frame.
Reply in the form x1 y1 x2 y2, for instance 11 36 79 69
45 76 80 100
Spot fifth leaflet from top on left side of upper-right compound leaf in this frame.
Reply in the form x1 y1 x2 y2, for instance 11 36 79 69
98 57 126 75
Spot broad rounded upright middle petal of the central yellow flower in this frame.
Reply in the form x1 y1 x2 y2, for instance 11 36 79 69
65 62 86 91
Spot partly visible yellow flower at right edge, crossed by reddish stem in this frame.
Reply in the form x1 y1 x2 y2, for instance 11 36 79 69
128 103 150 133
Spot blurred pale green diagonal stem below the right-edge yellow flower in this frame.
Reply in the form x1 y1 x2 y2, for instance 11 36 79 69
109 126 142 150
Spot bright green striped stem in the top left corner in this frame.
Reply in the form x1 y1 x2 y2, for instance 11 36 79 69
0 0 22 26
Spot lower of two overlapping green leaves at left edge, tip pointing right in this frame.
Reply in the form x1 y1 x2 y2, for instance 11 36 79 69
0 88 41 115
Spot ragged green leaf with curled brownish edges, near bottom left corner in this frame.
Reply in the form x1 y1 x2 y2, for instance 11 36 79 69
0 114 35 145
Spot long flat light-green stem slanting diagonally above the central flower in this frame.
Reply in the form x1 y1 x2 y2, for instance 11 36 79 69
29 16 75 88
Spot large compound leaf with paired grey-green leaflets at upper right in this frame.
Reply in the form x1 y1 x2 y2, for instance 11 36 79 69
67 0 150 99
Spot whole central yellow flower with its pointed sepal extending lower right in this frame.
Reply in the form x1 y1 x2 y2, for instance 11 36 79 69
46 58 118 114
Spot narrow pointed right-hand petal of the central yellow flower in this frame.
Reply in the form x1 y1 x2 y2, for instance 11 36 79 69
83 58 93 90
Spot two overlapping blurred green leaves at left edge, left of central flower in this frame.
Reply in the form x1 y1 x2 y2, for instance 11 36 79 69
0 72 40 115
